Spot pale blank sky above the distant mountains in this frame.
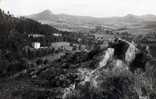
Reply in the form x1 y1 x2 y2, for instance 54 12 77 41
0 0 156 17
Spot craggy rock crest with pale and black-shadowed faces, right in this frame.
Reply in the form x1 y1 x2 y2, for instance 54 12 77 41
99 38 149 71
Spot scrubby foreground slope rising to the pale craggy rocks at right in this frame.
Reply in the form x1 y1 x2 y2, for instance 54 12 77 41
0 39 156 99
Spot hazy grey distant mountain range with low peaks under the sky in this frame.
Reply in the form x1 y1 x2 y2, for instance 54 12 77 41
26 10 156 32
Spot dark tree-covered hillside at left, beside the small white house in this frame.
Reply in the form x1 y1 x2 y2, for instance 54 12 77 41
0 9 63 77
